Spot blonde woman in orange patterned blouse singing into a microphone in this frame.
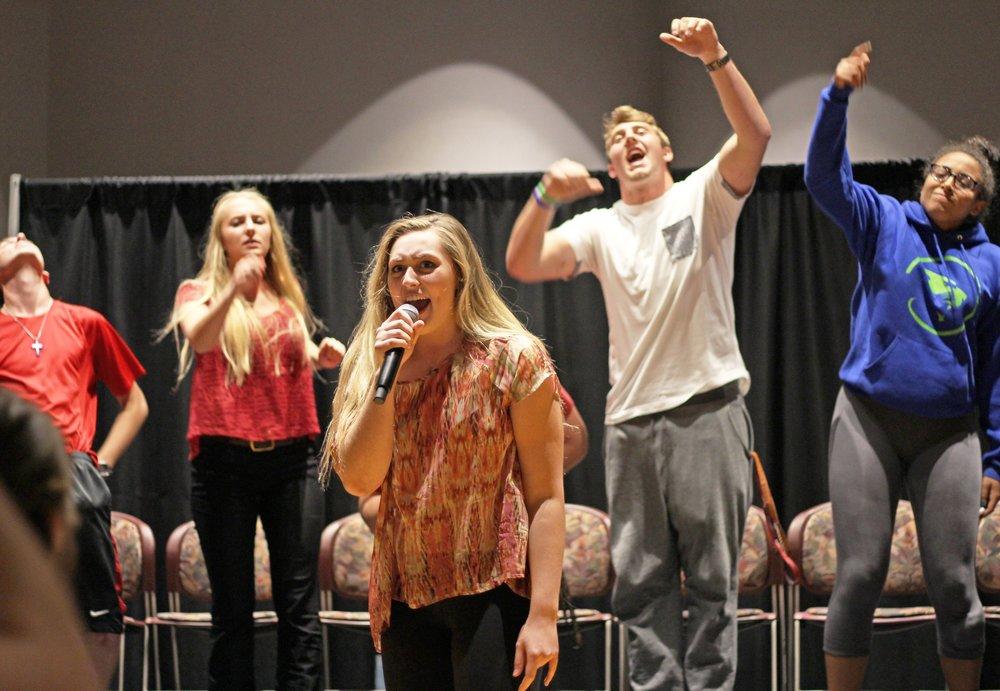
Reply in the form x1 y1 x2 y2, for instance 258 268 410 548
321 214 565 689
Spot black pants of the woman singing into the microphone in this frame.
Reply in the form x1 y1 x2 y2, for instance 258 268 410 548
382 585 530 691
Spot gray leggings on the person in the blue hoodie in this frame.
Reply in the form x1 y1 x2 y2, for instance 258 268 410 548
823 389 985 659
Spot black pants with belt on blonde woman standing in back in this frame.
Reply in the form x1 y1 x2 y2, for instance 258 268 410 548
191 439 323 689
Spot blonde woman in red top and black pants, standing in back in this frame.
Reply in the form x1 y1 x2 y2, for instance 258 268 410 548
166 189 344 689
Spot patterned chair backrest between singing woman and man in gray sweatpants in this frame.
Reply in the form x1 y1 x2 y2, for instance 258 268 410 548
563 504 615 597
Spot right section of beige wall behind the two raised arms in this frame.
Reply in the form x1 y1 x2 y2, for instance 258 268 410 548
661 0 1000 165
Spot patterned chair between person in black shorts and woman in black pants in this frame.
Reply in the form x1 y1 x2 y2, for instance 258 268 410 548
111 511 160 691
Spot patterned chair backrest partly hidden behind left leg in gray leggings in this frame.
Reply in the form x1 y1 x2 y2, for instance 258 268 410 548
788 501 926 596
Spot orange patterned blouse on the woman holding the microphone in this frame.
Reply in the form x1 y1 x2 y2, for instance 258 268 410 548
368 336 555 649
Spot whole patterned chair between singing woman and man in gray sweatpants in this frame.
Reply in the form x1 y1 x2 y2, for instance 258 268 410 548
557 504 612 689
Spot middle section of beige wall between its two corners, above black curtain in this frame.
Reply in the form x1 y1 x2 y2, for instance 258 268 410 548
43 0 657 176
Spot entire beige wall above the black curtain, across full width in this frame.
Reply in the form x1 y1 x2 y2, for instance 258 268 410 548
0 0 1000 232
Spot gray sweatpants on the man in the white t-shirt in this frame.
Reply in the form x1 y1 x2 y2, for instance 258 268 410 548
604 394 752 691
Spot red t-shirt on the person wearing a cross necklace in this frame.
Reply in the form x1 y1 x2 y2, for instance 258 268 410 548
0 300 146 462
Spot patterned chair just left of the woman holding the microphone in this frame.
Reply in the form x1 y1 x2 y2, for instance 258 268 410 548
319 513 375 688
